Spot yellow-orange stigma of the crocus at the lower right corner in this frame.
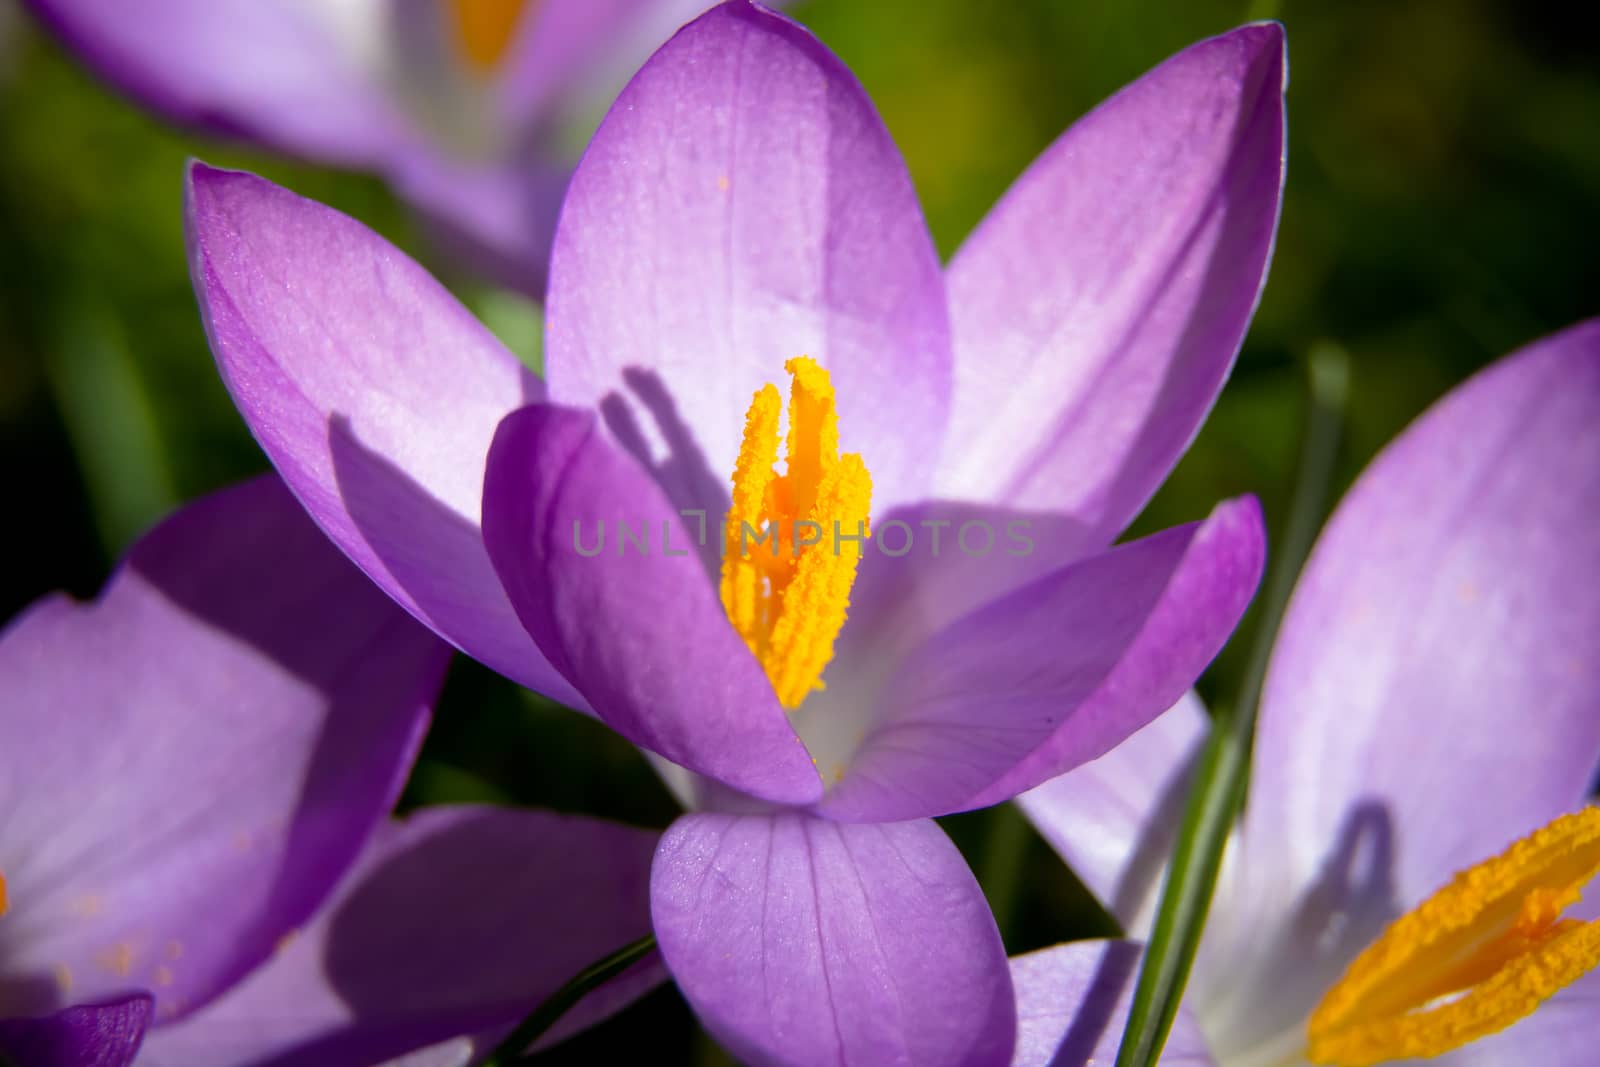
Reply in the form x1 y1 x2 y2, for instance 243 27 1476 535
1307 808 1600 1067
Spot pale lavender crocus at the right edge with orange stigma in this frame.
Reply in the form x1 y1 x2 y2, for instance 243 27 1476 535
1024 322 1600 1067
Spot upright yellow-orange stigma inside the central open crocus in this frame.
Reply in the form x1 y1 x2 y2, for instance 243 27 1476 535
722 355 872 709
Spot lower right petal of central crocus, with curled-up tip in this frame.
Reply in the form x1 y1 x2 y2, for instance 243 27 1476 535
821 498 1266 821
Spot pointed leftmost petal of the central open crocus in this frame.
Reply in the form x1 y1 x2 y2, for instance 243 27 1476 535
186 163 581 705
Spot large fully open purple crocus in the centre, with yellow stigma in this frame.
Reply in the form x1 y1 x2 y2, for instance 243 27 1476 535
187 2 1283 1064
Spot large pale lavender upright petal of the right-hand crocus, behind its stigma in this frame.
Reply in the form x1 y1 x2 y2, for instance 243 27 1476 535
1197 322 1600 1051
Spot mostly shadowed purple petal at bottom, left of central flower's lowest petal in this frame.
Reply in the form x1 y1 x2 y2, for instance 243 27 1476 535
139 808 666 1067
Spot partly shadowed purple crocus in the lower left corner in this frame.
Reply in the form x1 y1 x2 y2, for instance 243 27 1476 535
0 478 659 1067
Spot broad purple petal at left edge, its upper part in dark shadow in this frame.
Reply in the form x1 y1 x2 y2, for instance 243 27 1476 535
0 478 448 1021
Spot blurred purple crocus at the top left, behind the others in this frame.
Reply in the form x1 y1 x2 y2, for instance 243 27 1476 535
27 0 726 296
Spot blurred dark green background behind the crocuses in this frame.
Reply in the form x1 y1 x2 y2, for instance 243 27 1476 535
0 0 1600 1064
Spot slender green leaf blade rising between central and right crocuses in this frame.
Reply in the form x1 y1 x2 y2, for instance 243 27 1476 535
1117 344 1349 1067
